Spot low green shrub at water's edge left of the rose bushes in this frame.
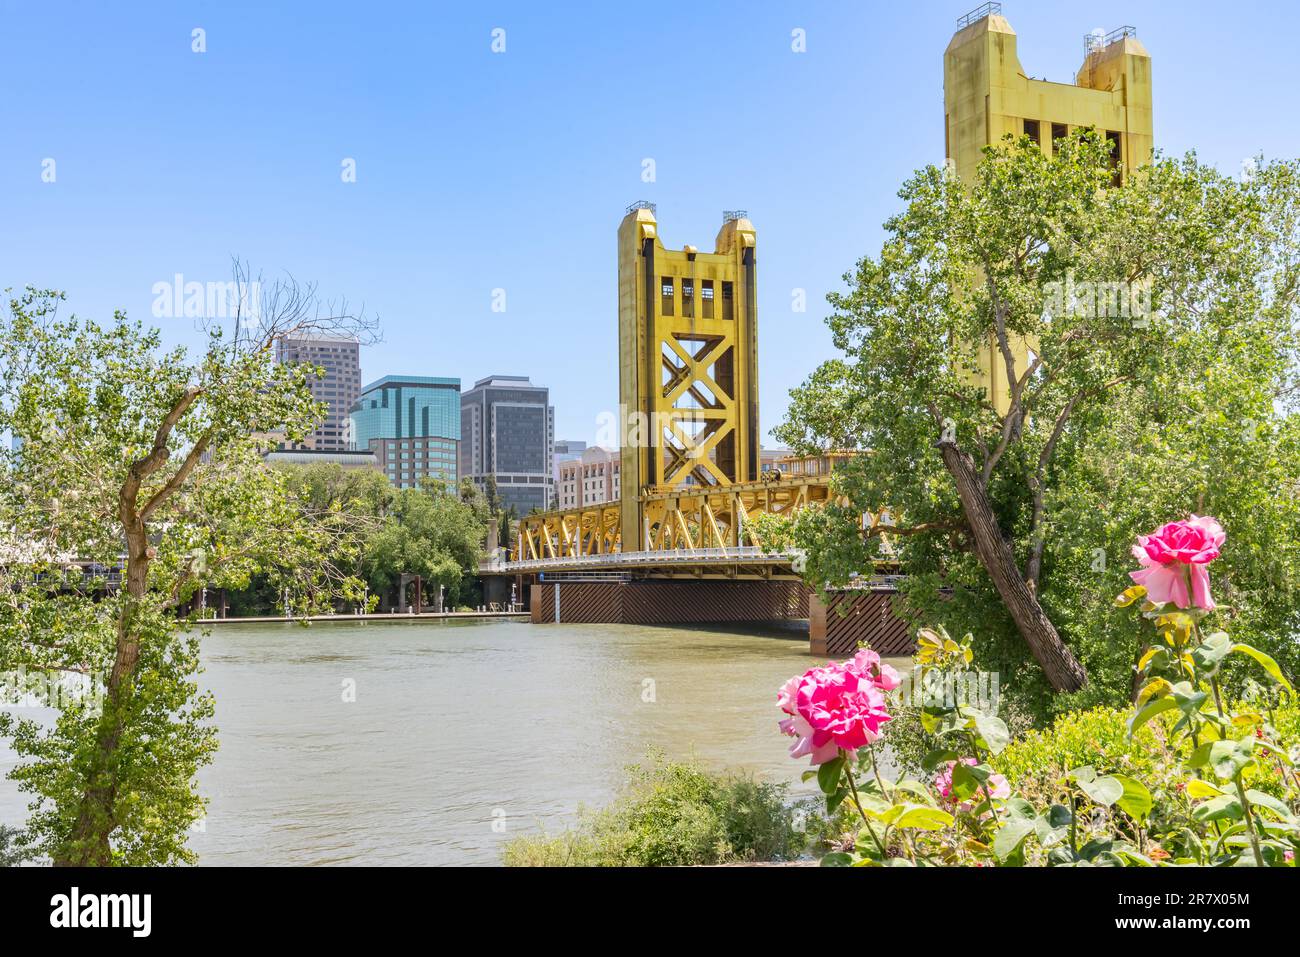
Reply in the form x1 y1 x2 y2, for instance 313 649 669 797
503 752 806 867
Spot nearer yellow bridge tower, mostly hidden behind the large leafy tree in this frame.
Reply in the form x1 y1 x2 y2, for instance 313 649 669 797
944 3 1154 412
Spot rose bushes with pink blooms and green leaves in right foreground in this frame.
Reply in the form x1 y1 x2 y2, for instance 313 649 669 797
777 516 1300 867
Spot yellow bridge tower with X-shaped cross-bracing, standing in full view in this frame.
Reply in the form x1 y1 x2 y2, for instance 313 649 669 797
619 203 759 551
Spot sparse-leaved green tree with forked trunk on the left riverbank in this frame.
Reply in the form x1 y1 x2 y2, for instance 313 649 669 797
0 264 377 865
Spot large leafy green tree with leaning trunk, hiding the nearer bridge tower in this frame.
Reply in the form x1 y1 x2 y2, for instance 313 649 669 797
777 134 1300 690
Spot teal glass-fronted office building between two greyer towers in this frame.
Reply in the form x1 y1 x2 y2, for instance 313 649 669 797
352 376 460 489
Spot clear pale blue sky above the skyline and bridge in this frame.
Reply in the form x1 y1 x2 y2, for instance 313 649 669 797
0 0 1300 443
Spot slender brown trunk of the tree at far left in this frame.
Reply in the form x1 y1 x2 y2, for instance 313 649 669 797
53 523 148 867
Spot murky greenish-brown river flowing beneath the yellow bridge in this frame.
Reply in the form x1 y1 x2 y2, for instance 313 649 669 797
0 620 909 865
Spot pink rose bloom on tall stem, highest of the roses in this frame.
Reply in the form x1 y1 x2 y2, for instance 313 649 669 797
1128 515 1227 611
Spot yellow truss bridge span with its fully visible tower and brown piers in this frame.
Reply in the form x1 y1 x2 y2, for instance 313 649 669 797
480 203 878 654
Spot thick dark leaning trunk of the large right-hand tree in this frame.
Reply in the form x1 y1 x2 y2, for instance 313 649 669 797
939 442 1088 692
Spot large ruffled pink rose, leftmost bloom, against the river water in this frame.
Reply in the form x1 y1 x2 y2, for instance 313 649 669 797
776 651 897 765
